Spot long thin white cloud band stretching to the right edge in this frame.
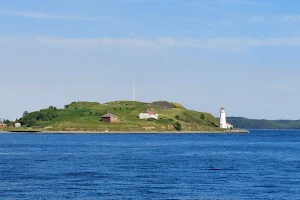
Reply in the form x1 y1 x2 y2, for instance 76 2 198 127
37 37 300 51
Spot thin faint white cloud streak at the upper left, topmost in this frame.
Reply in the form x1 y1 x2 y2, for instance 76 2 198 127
0 10 112 21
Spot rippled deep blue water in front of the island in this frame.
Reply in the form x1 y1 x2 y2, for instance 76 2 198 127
0 130 300 199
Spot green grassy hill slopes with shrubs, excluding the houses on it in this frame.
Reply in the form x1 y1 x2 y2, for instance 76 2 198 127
13 101 220 132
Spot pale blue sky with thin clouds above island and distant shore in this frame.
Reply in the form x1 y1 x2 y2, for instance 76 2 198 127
0 0 300 119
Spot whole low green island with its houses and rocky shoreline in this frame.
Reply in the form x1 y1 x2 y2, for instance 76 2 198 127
0 101 248 133
